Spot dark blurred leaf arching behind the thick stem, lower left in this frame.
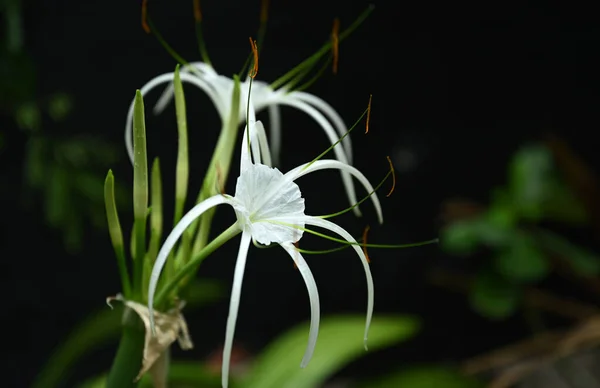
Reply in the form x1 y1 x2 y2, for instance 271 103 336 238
33 279 222 388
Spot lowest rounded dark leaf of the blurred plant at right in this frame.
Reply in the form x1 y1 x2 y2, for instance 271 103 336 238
469 271 520 319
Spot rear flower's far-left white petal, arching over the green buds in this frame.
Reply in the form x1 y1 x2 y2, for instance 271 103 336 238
125 73 227 164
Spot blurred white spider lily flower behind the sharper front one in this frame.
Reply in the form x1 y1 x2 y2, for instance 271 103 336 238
125 62 361 216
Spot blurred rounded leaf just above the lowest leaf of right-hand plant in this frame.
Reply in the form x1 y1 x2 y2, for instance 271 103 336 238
494 233 550 282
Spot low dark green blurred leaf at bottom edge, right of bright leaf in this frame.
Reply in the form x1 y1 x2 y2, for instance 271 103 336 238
359 365 485 388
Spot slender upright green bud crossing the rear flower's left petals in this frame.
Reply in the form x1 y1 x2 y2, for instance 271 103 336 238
173 65 189 225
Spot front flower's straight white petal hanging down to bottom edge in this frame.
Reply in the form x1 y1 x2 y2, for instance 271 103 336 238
221 230 252 388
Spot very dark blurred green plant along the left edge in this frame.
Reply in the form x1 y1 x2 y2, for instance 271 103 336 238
0 0 125 253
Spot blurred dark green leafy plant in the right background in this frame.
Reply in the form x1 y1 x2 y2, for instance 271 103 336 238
441 145 600 319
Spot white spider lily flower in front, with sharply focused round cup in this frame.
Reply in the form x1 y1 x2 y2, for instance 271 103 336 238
148 121 383 387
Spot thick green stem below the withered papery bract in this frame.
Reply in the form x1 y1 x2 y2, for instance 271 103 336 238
106 308 145 388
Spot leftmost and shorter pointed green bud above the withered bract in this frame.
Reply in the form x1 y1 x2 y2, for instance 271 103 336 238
104 170 131 298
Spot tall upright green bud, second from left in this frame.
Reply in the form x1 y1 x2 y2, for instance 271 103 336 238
133 90 148 292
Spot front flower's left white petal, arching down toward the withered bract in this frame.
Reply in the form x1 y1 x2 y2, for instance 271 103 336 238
148 195 237 327
